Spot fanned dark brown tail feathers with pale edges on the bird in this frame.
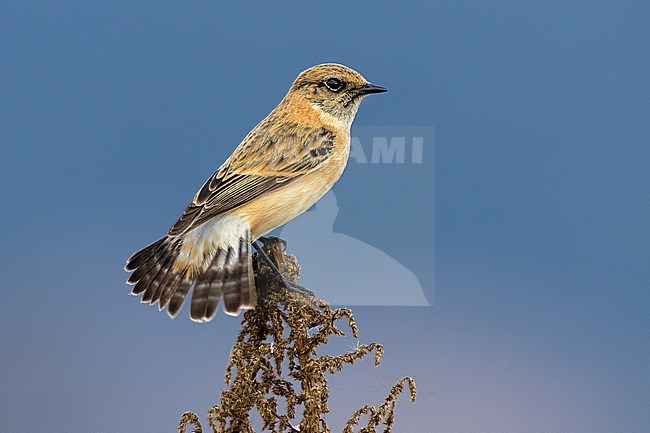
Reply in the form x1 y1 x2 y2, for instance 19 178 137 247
125 233 256 322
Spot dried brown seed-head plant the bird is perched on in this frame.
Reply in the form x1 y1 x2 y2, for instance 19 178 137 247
178 238 415 433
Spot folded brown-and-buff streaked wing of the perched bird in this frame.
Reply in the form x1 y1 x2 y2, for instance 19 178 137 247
168 124 334 236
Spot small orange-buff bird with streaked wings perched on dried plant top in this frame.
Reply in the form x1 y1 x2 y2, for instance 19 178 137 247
125 63 387 322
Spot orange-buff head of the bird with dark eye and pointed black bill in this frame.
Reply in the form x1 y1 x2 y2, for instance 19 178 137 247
289 63 388 126
